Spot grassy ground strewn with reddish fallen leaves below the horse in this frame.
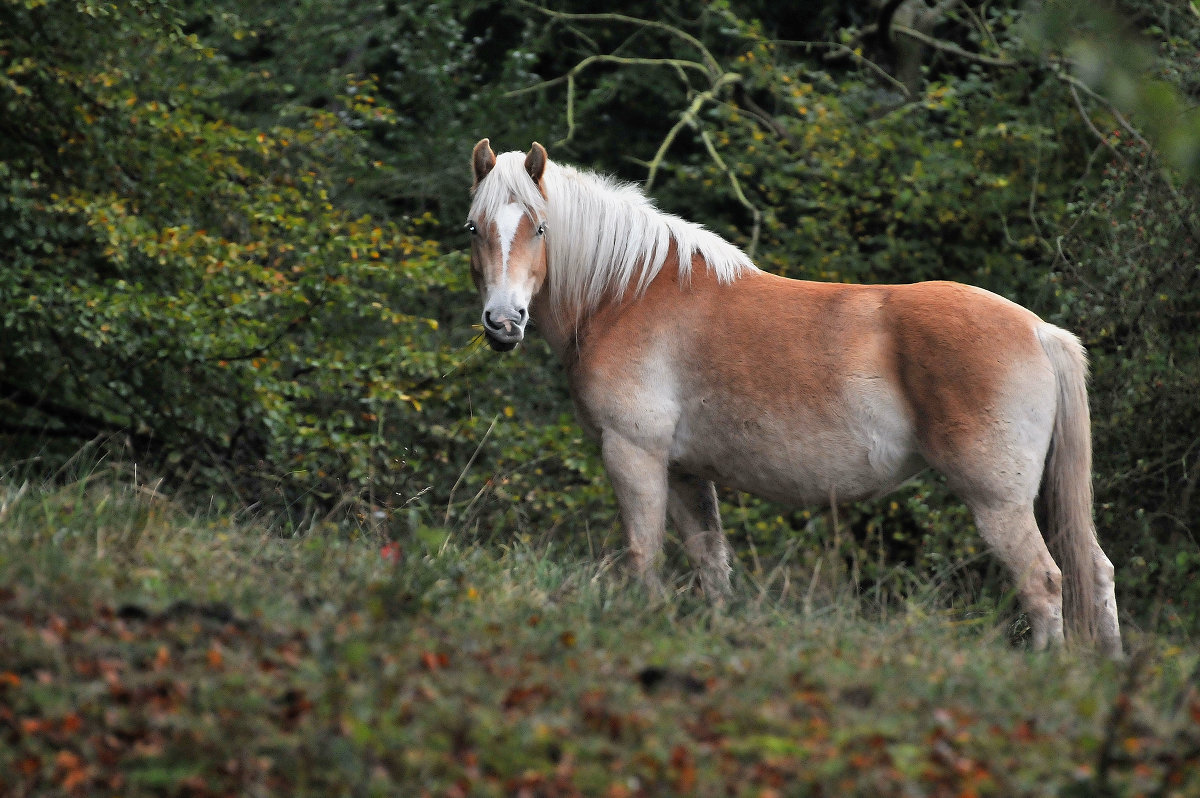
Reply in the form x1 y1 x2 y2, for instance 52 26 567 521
0 468 1200 796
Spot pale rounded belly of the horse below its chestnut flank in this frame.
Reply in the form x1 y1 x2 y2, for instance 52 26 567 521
671 378 925 504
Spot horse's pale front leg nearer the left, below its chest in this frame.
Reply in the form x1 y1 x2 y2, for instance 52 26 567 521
601 430 667 596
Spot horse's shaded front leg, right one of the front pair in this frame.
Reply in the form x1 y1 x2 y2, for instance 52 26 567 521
667 470 732 600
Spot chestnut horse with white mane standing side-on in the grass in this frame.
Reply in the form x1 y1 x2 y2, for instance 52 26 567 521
467 139 1121 655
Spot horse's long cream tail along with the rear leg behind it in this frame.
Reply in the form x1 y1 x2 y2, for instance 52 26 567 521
1038 324 1121 654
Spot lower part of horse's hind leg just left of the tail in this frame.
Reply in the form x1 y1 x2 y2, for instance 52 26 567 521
971 503 1064 650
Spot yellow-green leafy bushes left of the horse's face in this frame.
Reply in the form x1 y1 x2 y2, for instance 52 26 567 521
0 4 475 511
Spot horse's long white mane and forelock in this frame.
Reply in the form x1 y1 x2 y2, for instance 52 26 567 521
470 152 757 314
